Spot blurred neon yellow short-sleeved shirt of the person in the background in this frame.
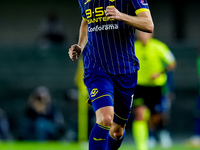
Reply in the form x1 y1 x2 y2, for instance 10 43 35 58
135 38 175 86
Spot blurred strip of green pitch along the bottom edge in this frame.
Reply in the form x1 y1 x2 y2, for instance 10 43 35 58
0 142 200 150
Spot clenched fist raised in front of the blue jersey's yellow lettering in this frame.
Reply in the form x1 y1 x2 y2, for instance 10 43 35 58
106 6 122 21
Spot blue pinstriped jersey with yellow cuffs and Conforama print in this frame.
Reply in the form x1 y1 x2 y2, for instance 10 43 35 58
79 0 149 75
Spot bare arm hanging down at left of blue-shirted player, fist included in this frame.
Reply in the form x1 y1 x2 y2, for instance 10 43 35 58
68 19 88 61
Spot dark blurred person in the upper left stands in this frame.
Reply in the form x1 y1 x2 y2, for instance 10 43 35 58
39 12 65 49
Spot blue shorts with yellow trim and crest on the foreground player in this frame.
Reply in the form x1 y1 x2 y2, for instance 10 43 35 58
84 68 137 125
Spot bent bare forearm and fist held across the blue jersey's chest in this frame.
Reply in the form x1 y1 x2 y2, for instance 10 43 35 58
106 6 154 33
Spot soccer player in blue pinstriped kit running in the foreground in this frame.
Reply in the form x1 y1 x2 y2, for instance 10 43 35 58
68 0 154 150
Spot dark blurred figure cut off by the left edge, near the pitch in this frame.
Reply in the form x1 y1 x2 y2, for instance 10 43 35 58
0 109 11 141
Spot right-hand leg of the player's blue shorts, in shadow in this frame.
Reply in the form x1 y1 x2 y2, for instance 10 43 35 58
114 73 137 125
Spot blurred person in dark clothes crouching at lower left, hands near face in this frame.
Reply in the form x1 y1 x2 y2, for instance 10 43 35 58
22 86 65 141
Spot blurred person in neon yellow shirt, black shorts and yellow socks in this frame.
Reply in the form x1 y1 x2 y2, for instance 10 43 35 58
132 31 175 150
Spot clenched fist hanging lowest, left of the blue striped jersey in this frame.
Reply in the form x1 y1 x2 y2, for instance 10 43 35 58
68 44 82 61
